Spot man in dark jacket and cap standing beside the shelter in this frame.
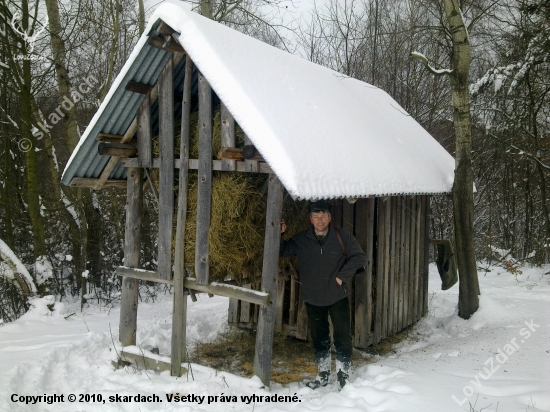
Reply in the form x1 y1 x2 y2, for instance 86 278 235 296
280 201 367 389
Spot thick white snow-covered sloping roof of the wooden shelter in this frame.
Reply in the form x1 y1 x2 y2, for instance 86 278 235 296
63 4 454 199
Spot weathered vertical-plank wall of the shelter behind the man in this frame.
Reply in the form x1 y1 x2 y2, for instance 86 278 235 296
229 195 429 348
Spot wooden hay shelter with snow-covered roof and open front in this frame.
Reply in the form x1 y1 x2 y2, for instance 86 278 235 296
62 5 453 385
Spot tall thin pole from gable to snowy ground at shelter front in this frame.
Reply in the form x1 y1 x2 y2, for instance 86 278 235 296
170 56 193 376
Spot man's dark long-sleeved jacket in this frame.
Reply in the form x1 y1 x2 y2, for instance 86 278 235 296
280 225 367 306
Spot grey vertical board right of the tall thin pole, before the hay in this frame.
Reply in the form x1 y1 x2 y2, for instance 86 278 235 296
195 73 212 285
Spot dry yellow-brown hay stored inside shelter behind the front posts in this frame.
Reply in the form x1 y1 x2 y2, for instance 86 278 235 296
153 109 309 288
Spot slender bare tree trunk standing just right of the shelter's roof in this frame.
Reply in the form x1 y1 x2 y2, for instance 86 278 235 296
444 0 480 319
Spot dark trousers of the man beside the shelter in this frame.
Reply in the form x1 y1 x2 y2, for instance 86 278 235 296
306 297 353 370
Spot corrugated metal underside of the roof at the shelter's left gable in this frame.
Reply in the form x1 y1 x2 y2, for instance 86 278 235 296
62 20 198 185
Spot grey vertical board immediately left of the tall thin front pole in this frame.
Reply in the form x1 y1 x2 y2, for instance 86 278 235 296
158 58 174 279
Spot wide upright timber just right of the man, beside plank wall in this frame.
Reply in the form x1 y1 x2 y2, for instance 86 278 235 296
353 198 374 349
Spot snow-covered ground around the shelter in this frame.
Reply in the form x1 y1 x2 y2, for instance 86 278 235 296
0 267 550 412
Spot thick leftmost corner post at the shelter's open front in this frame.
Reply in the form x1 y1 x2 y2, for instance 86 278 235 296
118 167 143 346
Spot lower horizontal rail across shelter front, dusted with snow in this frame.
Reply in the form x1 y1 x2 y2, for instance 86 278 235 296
115 266 270 306
